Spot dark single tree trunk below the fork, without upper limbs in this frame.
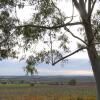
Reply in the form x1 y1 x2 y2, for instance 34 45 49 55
83 20 100 100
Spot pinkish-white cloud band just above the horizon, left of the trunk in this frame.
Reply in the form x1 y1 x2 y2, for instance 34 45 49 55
38 68 93 76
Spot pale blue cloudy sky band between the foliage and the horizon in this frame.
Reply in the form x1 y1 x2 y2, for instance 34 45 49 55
0 58 93 76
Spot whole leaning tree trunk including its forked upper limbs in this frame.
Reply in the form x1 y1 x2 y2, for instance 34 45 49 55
72 0 100 100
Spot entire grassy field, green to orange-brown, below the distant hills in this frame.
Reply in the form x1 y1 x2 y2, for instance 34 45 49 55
0 83 96 100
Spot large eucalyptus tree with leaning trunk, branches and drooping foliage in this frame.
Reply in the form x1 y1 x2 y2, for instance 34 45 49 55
0 0 100 100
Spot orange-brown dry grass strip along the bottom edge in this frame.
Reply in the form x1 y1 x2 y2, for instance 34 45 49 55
0 95 96 100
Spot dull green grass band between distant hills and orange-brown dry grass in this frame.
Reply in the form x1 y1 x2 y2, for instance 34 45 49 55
0 84 96 96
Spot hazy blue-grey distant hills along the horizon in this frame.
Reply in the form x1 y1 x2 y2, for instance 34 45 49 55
0 76 95 82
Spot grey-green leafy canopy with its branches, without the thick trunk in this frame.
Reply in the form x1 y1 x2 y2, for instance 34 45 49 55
0 0 100 73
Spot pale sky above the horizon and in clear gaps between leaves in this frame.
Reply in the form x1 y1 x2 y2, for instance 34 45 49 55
0 2 93 76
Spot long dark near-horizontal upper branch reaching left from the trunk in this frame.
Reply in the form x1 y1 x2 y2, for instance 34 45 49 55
15 22 82 30
